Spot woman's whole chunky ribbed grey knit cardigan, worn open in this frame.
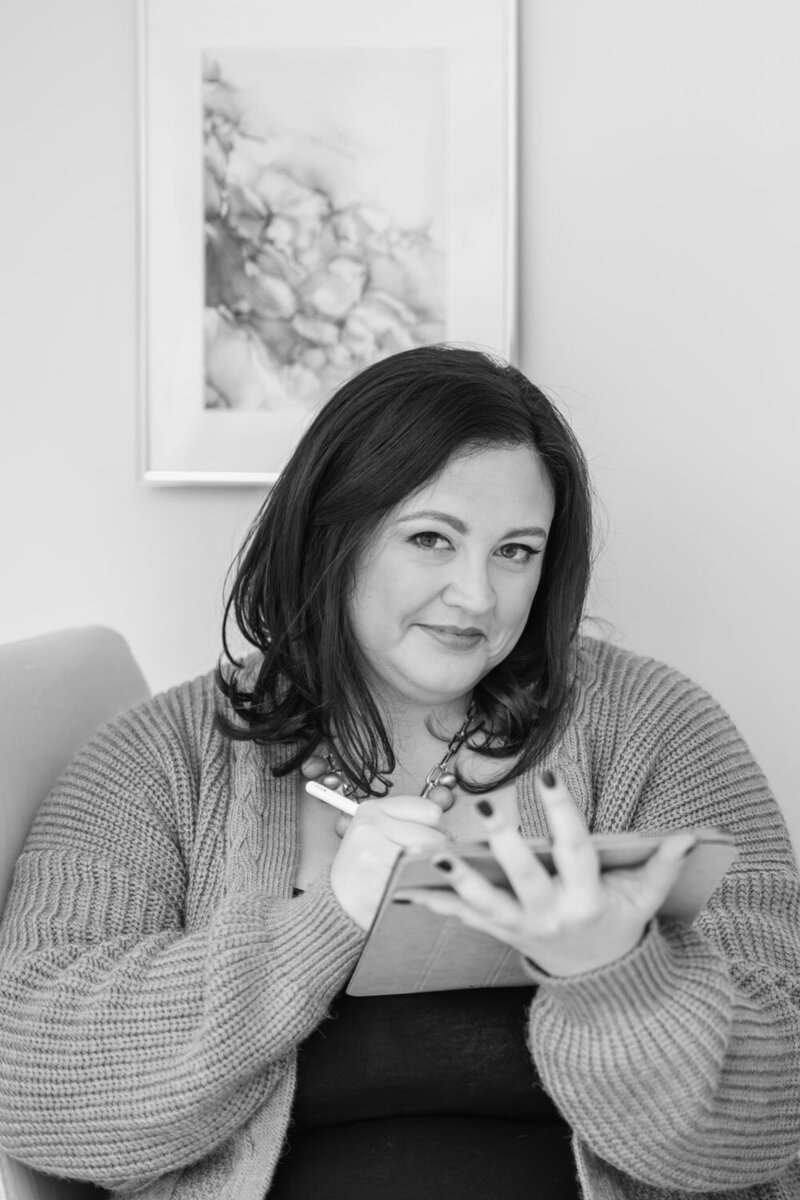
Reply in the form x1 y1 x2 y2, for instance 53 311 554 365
0 640 800 1200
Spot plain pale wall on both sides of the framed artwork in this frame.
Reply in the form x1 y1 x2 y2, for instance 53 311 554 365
0 0 800 846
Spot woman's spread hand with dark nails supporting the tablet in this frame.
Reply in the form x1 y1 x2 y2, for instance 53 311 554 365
398 773 693 976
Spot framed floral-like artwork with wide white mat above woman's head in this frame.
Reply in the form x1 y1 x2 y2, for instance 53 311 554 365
138 0 518 485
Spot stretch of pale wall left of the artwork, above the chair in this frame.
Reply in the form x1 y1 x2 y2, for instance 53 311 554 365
0 0 259 688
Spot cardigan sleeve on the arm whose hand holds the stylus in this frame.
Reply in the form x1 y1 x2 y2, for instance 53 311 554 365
0 686 363 1188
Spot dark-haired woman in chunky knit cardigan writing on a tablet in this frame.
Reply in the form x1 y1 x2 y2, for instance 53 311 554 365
0 347 800 1200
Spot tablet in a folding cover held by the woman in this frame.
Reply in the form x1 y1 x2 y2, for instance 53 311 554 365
347 827 736 996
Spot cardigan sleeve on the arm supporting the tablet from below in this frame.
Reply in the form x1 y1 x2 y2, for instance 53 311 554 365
530 655 800 1195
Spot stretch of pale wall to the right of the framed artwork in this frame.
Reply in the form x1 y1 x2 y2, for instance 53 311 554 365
522 0 800 847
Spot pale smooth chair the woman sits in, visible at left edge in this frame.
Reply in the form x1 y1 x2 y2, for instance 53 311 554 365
0 626 149 1200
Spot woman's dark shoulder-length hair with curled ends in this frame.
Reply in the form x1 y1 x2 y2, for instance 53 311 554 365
217 346 593 794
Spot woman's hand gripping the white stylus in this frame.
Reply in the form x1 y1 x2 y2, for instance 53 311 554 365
331 796 450 929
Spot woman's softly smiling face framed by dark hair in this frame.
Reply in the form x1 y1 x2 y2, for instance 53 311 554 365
351 445 553 708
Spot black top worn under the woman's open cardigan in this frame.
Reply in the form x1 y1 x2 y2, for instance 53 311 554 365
269 988 578 1200
